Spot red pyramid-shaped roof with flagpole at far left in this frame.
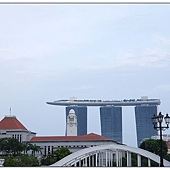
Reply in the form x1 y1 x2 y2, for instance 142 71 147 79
0 116 27 130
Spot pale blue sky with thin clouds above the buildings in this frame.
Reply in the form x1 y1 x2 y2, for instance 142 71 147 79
0 3 170 147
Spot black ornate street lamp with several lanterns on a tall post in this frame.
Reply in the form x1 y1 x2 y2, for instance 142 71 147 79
152 112 170 167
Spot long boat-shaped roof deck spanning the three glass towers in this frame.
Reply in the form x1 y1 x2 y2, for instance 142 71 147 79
46 99 161 106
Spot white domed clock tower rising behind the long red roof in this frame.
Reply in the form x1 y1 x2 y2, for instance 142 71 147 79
66 109 77 136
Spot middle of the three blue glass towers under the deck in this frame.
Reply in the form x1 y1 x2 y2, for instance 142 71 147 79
100 106 122 143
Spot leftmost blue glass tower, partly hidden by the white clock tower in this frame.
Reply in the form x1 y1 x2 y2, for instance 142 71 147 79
66 106 87 136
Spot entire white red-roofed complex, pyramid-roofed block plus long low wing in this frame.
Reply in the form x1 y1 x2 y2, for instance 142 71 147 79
0 115 117 157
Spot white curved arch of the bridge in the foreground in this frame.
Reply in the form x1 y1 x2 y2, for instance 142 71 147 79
50 144 170 167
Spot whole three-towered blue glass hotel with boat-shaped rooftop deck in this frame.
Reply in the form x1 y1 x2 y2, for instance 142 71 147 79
46 96 161 146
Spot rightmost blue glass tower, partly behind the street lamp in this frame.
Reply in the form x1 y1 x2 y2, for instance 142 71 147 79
135 105 157 147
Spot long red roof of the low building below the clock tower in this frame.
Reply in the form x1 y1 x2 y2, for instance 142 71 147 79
30 133 113 142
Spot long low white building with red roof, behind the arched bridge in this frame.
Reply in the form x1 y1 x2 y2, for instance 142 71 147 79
30 133 116 155
